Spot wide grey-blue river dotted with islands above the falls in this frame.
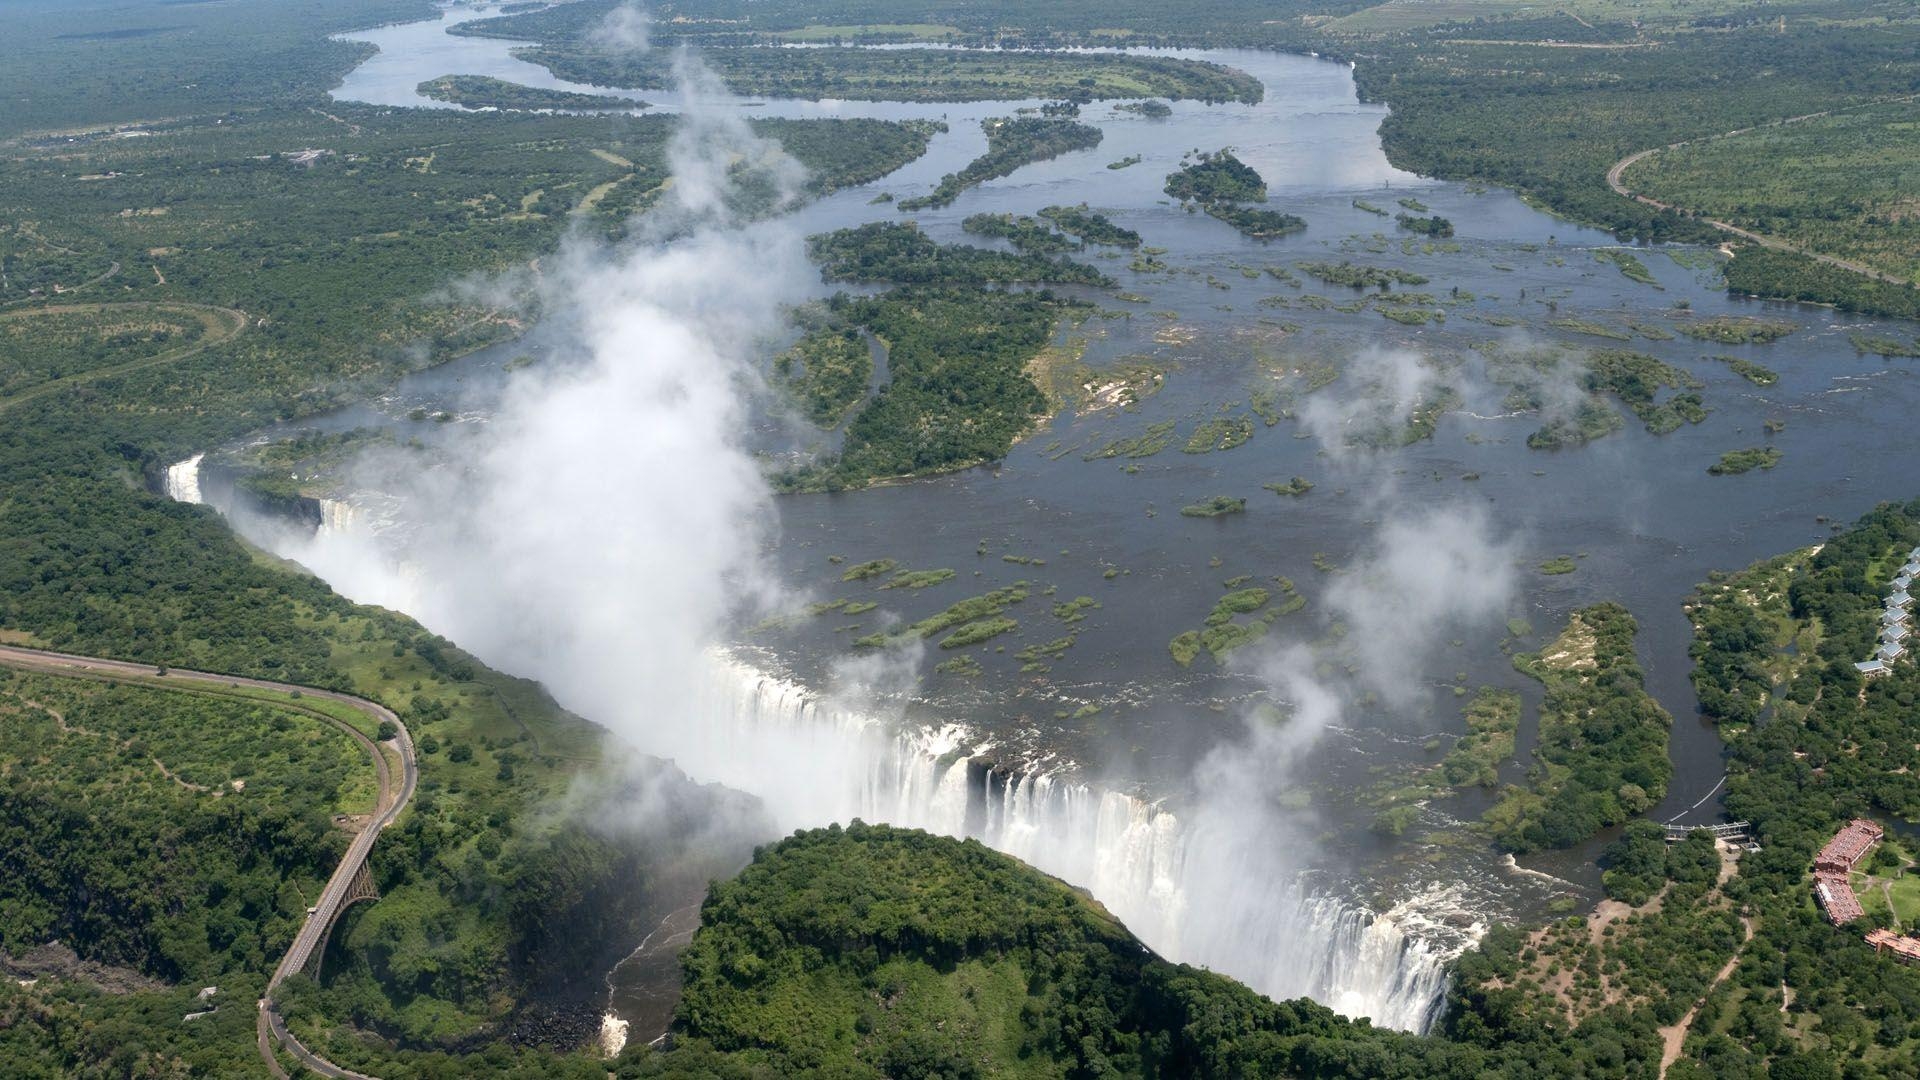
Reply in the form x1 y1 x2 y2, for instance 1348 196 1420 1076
187 0 1920 1026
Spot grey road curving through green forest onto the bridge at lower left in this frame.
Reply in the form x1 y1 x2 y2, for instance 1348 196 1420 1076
0 646 420 1080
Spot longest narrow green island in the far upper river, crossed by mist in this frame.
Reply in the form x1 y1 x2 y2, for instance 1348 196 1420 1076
516 38 1265 102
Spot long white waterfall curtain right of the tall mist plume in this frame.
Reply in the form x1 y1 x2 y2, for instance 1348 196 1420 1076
675 657 1482 1032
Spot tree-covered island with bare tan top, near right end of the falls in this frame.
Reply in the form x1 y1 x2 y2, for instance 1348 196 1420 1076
1484 603 1672 851
